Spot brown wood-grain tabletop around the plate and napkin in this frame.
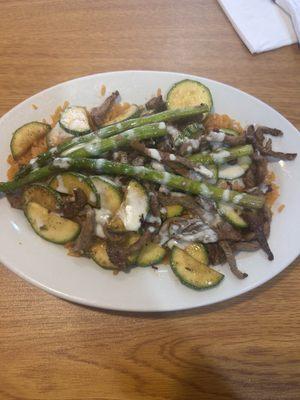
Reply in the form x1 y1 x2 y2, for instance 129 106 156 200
0 0 300 400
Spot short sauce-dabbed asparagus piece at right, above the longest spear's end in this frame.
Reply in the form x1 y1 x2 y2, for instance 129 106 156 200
188 144 253 164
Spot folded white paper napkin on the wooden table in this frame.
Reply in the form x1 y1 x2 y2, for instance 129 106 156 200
218 0 297 53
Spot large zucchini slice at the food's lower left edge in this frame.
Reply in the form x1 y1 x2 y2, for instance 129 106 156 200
24 201 80 244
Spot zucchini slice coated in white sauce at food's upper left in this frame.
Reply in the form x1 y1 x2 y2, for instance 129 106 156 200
59 106 91 136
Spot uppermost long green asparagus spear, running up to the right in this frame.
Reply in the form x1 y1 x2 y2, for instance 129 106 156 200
17 104 207 178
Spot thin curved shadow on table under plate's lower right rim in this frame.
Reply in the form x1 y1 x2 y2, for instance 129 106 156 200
74 258 299 319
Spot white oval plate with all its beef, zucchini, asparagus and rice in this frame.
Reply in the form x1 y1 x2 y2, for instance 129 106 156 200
0 71 300 312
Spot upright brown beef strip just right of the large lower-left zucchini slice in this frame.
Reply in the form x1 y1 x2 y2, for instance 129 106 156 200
73 206 96 254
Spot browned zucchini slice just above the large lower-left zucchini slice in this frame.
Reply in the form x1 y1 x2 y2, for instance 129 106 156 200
23 183 62 211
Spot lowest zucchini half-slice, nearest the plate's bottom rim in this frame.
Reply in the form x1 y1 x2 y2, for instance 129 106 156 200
171 246 224 290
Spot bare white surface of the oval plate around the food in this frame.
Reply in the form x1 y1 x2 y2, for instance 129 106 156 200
0 71 300 311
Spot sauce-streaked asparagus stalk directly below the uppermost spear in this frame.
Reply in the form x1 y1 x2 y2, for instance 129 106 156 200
61 122 167 158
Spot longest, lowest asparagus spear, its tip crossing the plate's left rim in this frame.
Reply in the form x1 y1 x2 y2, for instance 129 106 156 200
0 157 264 209
